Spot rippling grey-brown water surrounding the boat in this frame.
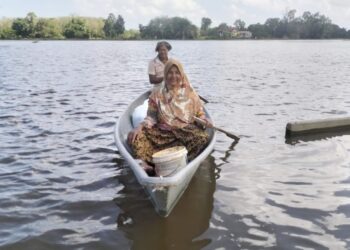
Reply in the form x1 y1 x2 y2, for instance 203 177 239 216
0 40 350 250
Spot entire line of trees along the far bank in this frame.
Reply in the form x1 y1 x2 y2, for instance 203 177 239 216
0 10 350 40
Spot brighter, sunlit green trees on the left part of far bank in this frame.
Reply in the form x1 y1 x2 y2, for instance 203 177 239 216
0 12 135 39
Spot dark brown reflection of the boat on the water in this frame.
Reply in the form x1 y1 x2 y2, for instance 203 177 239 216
115 156 218 249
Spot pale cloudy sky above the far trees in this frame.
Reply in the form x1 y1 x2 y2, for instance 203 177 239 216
0 0 350 29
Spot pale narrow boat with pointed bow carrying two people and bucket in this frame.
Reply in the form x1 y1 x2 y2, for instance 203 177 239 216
114 91 216 217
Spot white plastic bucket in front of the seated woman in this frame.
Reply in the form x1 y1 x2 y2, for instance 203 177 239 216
152 146 187 176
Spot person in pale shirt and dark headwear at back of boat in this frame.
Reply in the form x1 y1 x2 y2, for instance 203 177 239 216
148 41 171 88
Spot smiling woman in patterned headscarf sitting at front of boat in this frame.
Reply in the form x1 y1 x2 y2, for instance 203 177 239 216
128 59 212 174
